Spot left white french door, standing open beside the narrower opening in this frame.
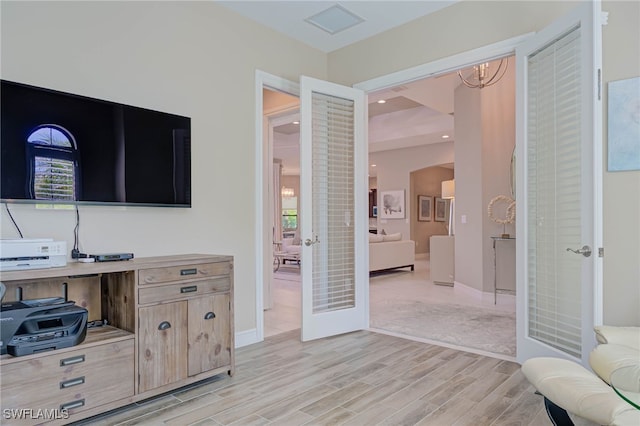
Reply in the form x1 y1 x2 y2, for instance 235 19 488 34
300 77 369 341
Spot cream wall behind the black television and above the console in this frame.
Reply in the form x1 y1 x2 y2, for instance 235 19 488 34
0 1 327 332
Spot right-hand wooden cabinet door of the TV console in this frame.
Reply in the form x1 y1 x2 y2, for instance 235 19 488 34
189 294 231 376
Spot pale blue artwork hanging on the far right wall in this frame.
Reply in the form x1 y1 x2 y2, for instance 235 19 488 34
607 77 640 172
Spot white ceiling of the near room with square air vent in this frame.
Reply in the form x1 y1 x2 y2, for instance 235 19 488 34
217 0 458 53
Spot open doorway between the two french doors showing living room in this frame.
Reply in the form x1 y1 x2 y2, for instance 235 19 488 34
369 59 516 359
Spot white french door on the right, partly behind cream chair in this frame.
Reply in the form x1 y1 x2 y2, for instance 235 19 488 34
516 2 602 364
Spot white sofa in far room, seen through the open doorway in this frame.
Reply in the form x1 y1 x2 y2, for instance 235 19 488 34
369 234 416 272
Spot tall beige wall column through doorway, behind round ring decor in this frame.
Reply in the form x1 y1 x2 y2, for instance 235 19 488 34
454 62 515 292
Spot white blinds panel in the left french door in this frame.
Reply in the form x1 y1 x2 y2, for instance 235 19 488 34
311 92 355 314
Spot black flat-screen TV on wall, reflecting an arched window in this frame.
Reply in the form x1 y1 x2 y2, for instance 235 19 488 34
0 80 191 207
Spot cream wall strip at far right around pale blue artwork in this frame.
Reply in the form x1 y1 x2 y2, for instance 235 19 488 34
602 1 640 325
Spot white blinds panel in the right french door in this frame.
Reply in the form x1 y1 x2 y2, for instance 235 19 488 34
526 27 583 358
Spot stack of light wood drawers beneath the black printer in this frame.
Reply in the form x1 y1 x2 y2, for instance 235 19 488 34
0 338 134 414
